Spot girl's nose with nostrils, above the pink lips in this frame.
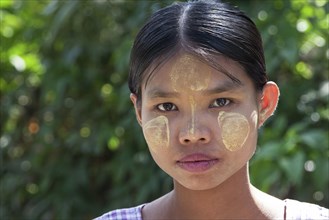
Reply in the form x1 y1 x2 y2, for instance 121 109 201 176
179 119 210 145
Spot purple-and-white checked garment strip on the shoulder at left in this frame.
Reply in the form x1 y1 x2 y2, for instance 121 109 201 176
94 204 145 220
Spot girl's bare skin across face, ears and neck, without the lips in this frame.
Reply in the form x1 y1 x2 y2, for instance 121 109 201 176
131 53 284 219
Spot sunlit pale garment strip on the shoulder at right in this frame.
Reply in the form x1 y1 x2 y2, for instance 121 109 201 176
284 199 329 220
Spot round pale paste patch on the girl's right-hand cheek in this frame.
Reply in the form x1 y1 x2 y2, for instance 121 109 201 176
218 112 250 151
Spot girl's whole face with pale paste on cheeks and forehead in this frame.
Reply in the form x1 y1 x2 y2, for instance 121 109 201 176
133 54 259 190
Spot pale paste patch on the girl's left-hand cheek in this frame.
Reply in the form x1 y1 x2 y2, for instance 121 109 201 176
143 116 169 152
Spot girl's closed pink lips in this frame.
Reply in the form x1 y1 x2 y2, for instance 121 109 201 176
176 153 219 173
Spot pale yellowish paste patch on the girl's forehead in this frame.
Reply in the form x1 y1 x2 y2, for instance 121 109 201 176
170 54 211 92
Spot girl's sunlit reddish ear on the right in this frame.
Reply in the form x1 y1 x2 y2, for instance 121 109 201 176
258 81 280 127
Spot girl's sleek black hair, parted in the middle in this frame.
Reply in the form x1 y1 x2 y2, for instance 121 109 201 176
128 0 267 100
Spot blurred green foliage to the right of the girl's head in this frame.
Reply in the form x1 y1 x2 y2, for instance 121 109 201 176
233 0 329 207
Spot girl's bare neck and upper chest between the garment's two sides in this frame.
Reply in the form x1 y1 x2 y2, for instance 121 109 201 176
143 165 284 220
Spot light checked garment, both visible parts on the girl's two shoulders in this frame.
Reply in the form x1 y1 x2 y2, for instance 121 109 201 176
95 199 329 220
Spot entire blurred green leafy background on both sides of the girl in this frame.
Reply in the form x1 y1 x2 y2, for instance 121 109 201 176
0 0 329 219
